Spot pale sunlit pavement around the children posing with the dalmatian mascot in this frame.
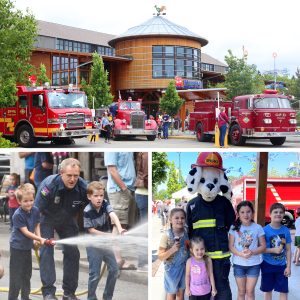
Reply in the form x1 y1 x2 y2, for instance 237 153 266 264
150 215 300 300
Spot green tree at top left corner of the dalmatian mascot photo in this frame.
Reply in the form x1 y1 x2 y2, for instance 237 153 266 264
152 152 169 194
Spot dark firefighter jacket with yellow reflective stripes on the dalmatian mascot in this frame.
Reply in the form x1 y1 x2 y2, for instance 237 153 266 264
187 194 235 259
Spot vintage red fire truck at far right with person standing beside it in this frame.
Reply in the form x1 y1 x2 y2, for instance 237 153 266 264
189 90 299 146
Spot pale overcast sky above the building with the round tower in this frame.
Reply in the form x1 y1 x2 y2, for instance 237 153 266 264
15 0 300 74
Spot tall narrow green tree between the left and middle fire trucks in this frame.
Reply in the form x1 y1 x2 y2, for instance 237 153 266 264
90 52 114 108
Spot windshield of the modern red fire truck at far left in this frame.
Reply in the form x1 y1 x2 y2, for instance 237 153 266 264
48 92 87 108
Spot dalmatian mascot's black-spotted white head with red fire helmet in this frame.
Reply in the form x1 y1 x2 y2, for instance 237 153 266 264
186 152 231 202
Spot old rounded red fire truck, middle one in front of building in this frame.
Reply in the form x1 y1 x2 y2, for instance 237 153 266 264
110 98 157 141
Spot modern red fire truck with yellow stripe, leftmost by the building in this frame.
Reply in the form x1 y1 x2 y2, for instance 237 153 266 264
0 86 93 147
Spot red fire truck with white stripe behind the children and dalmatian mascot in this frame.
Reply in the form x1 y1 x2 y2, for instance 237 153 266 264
231 177 300 227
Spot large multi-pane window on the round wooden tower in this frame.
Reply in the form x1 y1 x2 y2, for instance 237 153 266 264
152 45 201 80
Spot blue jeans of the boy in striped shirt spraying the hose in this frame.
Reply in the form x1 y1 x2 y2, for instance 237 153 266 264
86 247 119 300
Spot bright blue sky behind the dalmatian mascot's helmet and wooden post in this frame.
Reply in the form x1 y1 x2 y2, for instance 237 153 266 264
167 152 300 178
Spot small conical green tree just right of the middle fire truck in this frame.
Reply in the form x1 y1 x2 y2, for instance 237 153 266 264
160 80 184 117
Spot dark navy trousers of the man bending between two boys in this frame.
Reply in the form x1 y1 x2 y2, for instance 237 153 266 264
40 219 80 296
